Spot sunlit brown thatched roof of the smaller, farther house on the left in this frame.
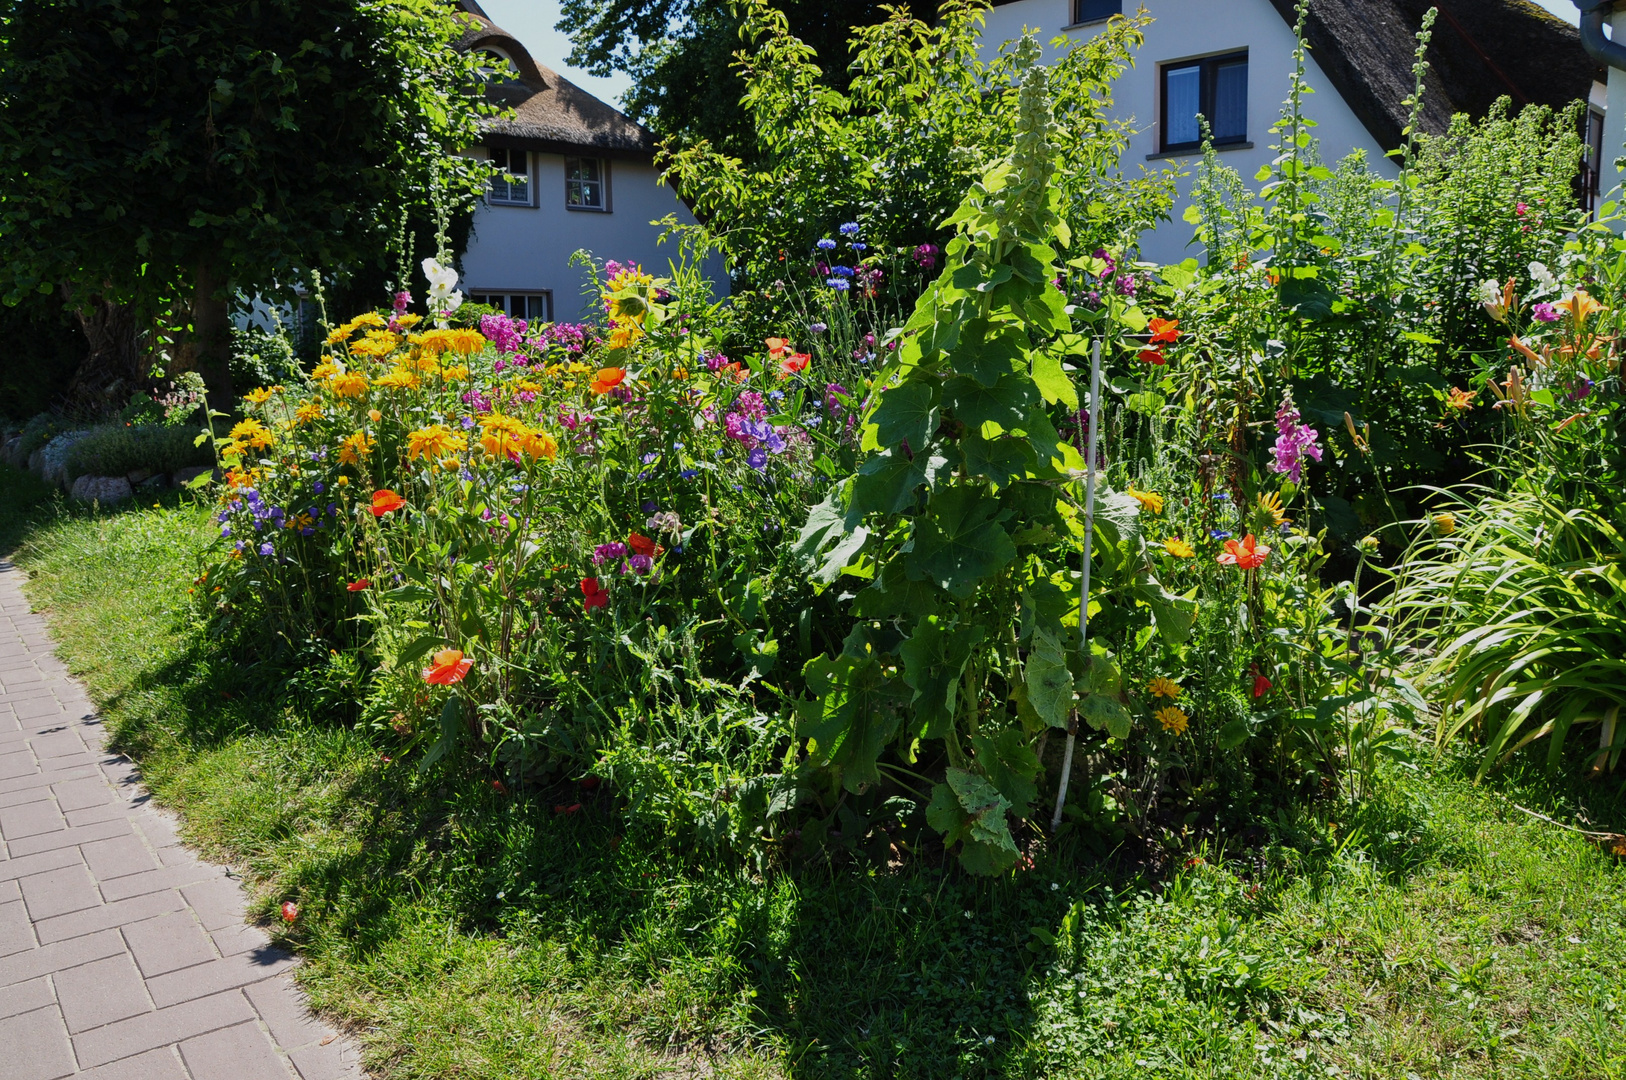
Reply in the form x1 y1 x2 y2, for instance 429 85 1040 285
457 0 655 156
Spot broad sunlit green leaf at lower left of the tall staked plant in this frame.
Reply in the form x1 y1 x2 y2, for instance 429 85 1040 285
797 652 899 792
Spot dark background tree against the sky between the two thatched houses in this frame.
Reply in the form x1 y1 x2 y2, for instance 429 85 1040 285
559 0 889 159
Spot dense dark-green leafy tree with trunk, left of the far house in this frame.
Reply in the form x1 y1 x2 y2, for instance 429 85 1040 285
0 0 488 400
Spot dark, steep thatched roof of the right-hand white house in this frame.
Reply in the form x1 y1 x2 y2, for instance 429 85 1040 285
1270 0 1606 150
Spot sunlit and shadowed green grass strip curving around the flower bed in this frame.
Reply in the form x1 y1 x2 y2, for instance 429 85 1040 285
0 467 1626 1080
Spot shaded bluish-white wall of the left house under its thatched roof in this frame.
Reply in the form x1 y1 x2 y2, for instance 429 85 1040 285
459 150 728 322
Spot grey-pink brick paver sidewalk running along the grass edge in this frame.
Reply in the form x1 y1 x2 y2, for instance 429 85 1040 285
0 560 361 1080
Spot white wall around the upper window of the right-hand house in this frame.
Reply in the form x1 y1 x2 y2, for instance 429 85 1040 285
982 0 1398 262
